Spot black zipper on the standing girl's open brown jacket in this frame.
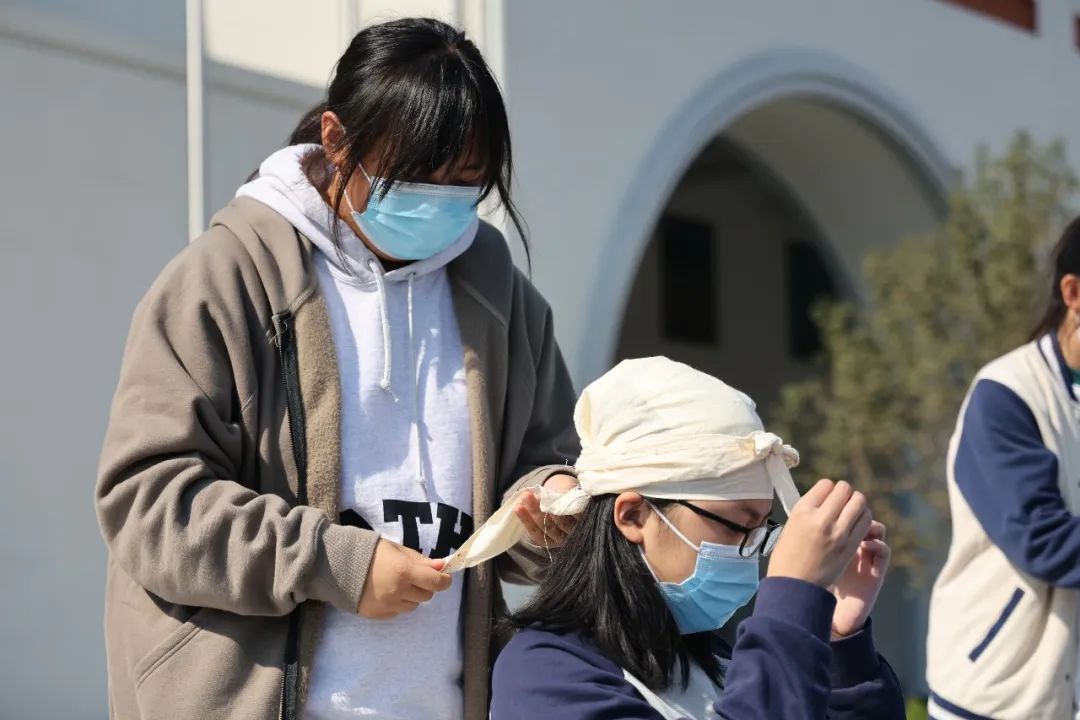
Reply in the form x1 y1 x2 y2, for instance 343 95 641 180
274 312 308 720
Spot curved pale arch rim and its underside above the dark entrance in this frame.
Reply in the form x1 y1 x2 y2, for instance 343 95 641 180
576 51 954 388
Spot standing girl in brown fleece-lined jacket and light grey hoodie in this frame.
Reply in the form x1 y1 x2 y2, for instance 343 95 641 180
96 19 577 720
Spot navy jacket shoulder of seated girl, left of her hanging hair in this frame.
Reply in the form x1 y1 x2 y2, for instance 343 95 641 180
490 629 662 720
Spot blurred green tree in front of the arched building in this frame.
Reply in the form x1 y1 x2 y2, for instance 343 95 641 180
774 133 1077 579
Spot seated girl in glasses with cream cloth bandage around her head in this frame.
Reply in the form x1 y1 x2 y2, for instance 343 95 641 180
442 358 904 720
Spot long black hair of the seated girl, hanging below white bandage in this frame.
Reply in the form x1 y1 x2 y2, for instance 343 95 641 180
507 495 720 691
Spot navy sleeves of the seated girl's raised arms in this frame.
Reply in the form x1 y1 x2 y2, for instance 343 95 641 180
715 578 904 720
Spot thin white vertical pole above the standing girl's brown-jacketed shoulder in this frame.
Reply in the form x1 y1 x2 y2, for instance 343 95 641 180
186 0 206 240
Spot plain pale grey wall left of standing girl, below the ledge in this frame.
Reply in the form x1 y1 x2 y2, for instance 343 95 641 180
0 14 313 719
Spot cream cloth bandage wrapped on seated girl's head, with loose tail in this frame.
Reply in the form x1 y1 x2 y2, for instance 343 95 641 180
446 357 799 572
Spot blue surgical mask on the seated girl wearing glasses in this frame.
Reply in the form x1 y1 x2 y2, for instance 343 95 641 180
638 503 758 635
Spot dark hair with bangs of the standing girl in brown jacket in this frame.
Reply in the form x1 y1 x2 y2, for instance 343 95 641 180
288 17 529 259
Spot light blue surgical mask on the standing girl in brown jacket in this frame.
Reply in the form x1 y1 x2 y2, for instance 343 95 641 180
346 162 481 260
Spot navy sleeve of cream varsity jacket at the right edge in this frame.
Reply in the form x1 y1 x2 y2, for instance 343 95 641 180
953 380 1080 588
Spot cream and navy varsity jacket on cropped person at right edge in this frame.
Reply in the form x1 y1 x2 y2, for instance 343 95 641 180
927 334 1080 720
